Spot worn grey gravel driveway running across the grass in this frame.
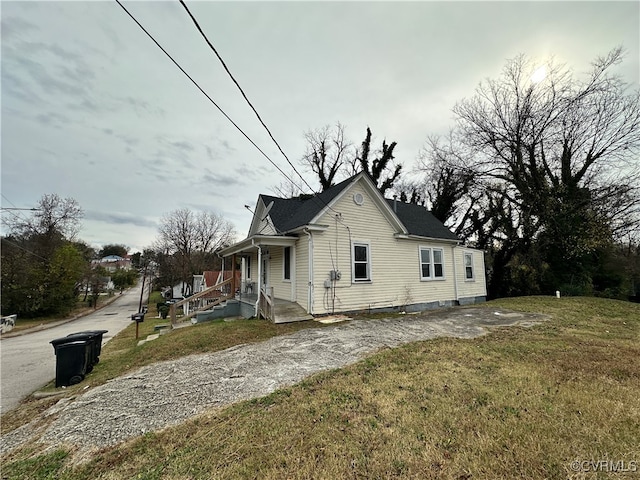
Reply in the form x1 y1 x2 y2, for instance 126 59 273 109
0 307 545 457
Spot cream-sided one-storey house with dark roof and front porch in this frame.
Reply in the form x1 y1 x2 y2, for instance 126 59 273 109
220 173 486 322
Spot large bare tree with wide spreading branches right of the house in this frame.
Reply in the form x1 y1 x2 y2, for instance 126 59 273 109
454 49 640 296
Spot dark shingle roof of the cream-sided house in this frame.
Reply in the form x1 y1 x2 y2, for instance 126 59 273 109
260 177 458 240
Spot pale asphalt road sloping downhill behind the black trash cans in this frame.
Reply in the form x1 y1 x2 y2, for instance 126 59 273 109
0 284 147 413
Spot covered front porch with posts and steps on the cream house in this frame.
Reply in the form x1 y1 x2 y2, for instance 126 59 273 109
220 235 313 323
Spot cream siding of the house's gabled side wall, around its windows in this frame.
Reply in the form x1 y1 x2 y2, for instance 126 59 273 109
312 184 461 314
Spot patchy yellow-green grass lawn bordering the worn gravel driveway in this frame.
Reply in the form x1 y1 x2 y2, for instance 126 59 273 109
2 297 640 479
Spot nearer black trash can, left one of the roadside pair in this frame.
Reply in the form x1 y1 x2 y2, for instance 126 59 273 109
49 337 93 387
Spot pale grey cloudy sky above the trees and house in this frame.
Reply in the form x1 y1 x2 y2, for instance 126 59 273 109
0 0 640 251
